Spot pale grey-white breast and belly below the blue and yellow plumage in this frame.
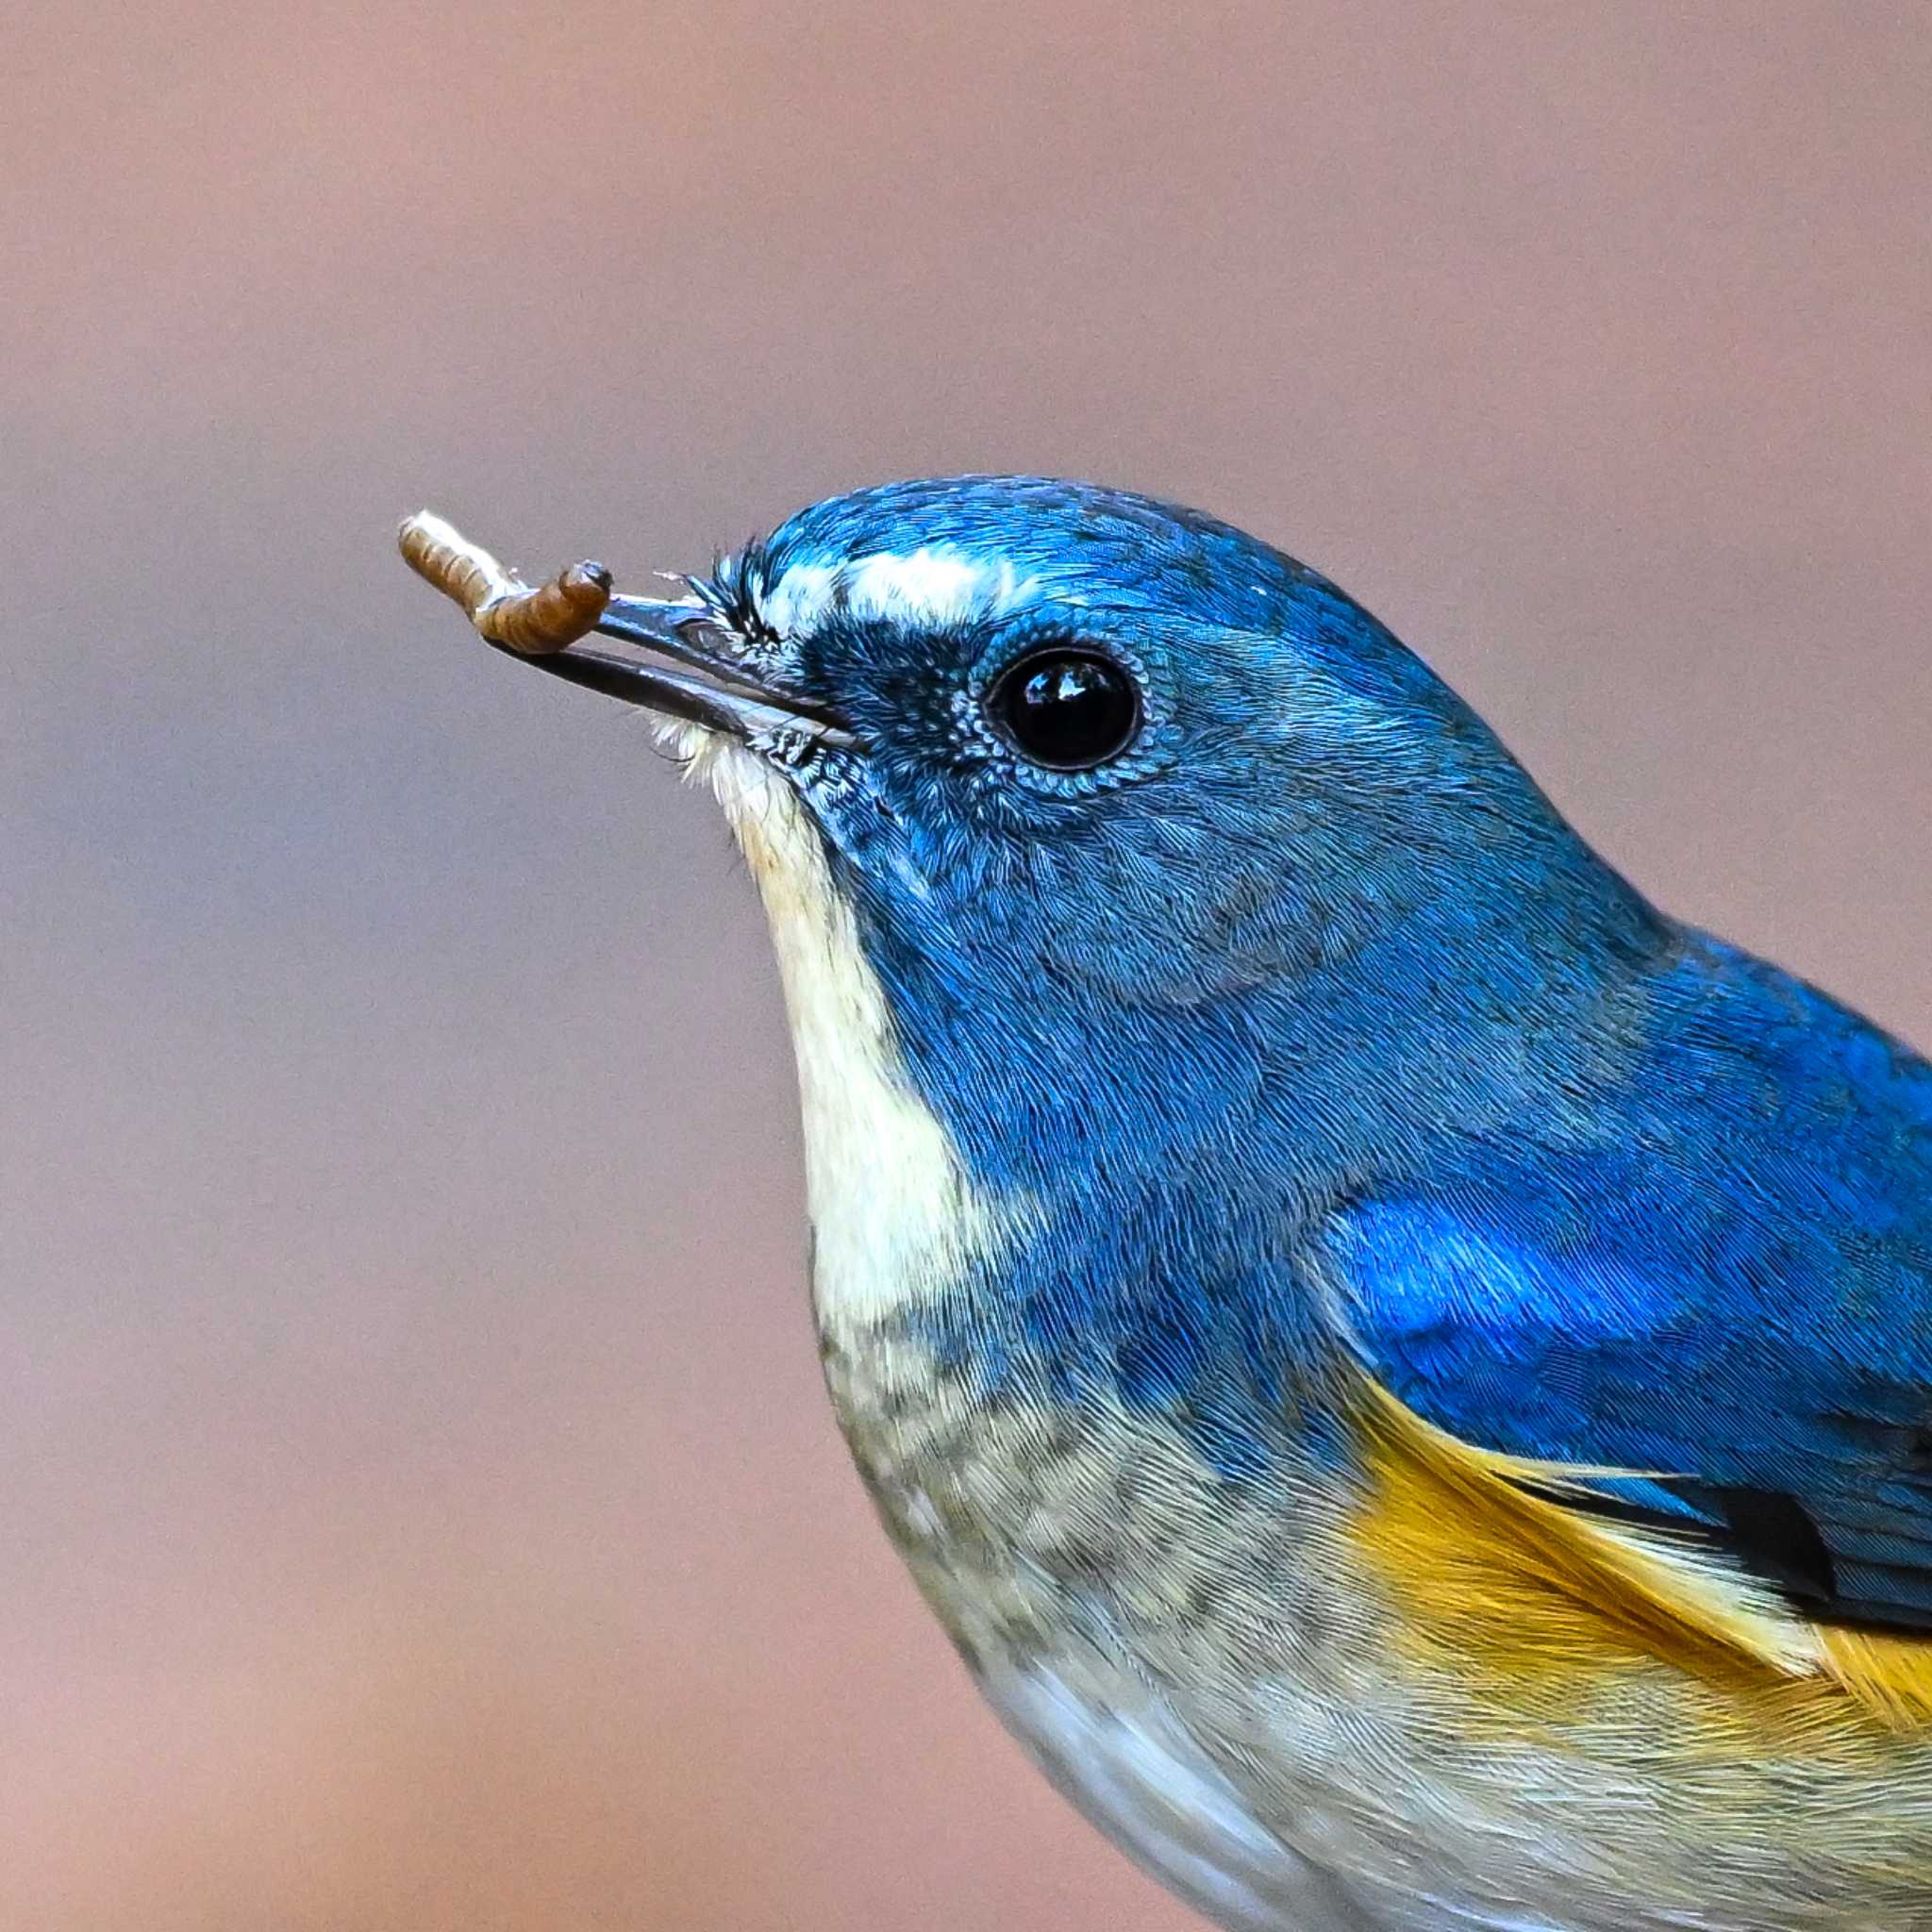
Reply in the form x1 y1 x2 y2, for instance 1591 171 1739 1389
827 1329 1932 1932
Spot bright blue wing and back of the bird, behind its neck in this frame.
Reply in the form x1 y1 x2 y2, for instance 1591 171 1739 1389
1325 935 1932 1626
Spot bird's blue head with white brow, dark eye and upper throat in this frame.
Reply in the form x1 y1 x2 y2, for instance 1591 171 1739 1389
491 477 1642 1221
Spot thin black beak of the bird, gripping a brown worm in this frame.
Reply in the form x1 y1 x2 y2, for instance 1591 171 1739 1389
494 597 852 748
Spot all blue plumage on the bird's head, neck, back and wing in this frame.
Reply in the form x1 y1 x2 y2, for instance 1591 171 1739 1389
711 479 1932 1623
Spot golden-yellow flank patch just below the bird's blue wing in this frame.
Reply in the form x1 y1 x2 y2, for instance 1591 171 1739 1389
1353 1379 1824 1689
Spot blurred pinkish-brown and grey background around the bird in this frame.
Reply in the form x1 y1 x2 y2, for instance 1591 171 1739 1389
0 0 1932 1932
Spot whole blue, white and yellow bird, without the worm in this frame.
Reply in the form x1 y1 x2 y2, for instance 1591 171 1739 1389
408 475 1932 1932
